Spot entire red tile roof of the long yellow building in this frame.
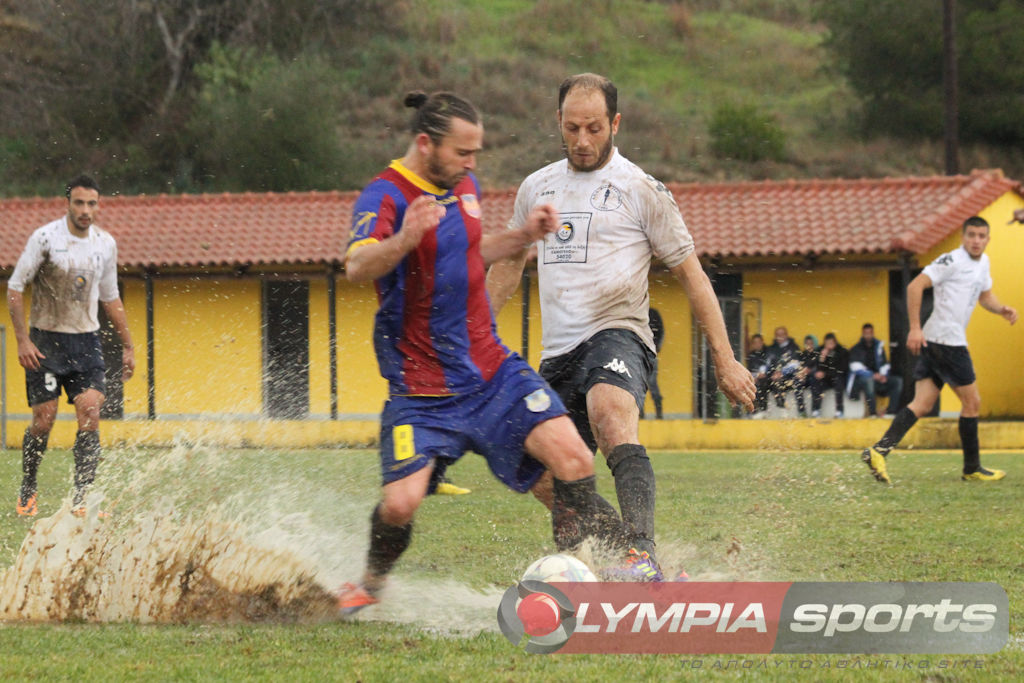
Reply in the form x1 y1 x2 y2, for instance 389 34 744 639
0 170 1021 269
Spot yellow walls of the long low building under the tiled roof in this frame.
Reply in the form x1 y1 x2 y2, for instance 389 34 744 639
2 193 1024 419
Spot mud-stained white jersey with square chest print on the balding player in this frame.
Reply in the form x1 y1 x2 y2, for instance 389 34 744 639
509 150 693 358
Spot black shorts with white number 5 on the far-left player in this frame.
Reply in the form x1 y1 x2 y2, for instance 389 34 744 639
25 328 106 407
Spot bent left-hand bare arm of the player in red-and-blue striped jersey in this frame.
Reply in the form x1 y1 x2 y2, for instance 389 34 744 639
345 195 444 283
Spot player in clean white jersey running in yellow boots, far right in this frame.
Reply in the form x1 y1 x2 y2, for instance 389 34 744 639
861 216 1017 483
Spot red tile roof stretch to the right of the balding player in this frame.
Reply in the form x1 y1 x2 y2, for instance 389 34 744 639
671 170 1021 257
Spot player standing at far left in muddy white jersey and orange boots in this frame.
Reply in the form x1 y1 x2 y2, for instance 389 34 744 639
7 175 135 517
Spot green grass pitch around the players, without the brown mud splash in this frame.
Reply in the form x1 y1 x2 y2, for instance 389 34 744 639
0 445 1024 681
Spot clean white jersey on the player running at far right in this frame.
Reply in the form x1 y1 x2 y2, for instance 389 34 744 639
923 247 992 346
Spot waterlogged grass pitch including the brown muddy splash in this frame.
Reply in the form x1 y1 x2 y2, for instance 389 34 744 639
0 444 1024 681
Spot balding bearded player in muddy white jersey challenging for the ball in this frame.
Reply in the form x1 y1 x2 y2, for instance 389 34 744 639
488 74 755 581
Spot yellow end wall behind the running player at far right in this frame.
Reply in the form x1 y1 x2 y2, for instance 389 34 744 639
918 193 1024 419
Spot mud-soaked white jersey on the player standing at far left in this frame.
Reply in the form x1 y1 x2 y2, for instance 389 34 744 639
7 216 118 334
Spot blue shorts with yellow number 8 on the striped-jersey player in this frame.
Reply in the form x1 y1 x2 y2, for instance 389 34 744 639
381 353 566 493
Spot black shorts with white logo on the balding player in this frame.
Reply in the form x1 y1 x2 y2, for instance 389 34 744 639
540 330 655 452
